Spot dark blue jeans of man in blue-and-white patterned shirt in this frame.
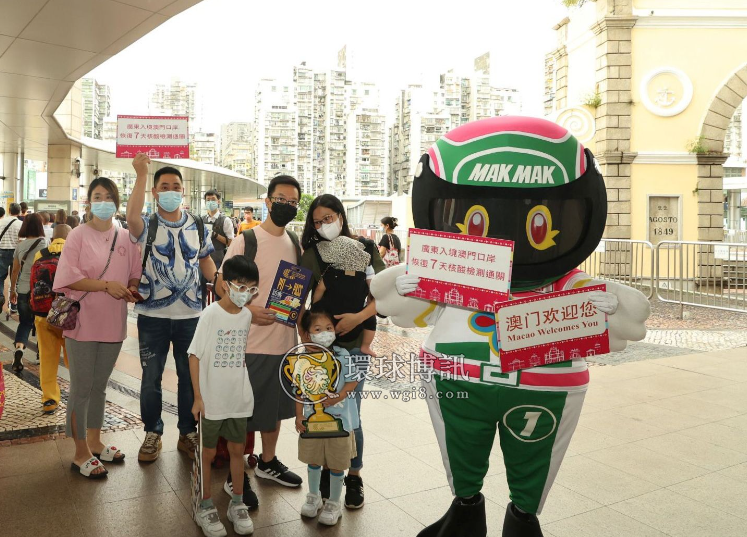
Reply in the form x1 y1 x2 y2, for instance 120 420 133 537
137 315 199 435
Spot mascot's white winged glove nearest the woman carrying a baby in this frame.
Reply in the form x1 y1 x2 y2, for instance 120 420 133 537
371 265 434 328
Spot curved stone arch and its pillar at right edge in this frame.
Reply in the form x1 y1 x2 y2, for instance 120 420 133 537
697 63 747 241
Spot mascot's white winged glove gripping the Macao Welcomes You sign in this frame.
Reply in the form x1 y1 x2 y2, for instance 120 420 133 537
589 280 651 352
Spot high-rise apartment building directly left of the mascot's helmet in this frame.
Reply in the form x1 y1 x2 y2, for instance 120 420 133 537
389 85 452 194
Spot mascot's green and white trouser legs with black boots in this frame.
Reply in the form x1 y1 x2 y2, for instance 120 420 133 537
418 379 585 537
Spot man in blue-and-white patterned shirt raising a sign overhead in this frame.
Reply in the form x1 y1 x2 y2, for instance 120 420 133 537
127 153 215 461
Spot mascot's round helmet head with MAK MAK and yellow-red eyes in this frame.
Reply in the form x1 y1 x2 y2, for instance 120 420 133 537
412 116 607 290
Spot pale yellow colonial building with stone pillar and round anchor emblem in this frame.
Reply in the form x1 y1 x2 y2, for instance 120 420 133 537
545 0 747 245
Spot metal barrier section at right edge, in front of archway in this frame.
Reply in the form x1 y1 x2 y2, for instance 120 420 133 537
656 241 747 312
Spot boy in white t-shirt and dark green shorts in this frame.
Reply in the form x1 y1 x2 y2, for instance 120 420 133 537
188 256 259 537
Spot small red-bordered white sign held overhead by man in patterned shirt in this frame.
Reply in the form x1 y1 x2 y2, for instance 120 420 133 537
117 116 189 159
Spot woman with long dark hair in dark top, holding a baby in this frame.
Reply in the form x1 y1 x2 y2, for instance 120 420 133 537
301 194 384 509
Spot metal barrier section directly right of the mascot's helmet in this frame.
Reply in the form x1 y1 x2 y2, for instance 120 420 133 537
579 239 655 298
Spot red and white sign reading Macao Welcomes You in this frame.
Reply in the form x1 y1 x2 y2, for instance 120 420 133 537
495 285 610 373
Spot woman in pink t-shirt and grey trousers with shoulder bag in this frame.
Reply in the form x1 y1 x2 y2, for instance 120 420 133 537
54 177 142 478
